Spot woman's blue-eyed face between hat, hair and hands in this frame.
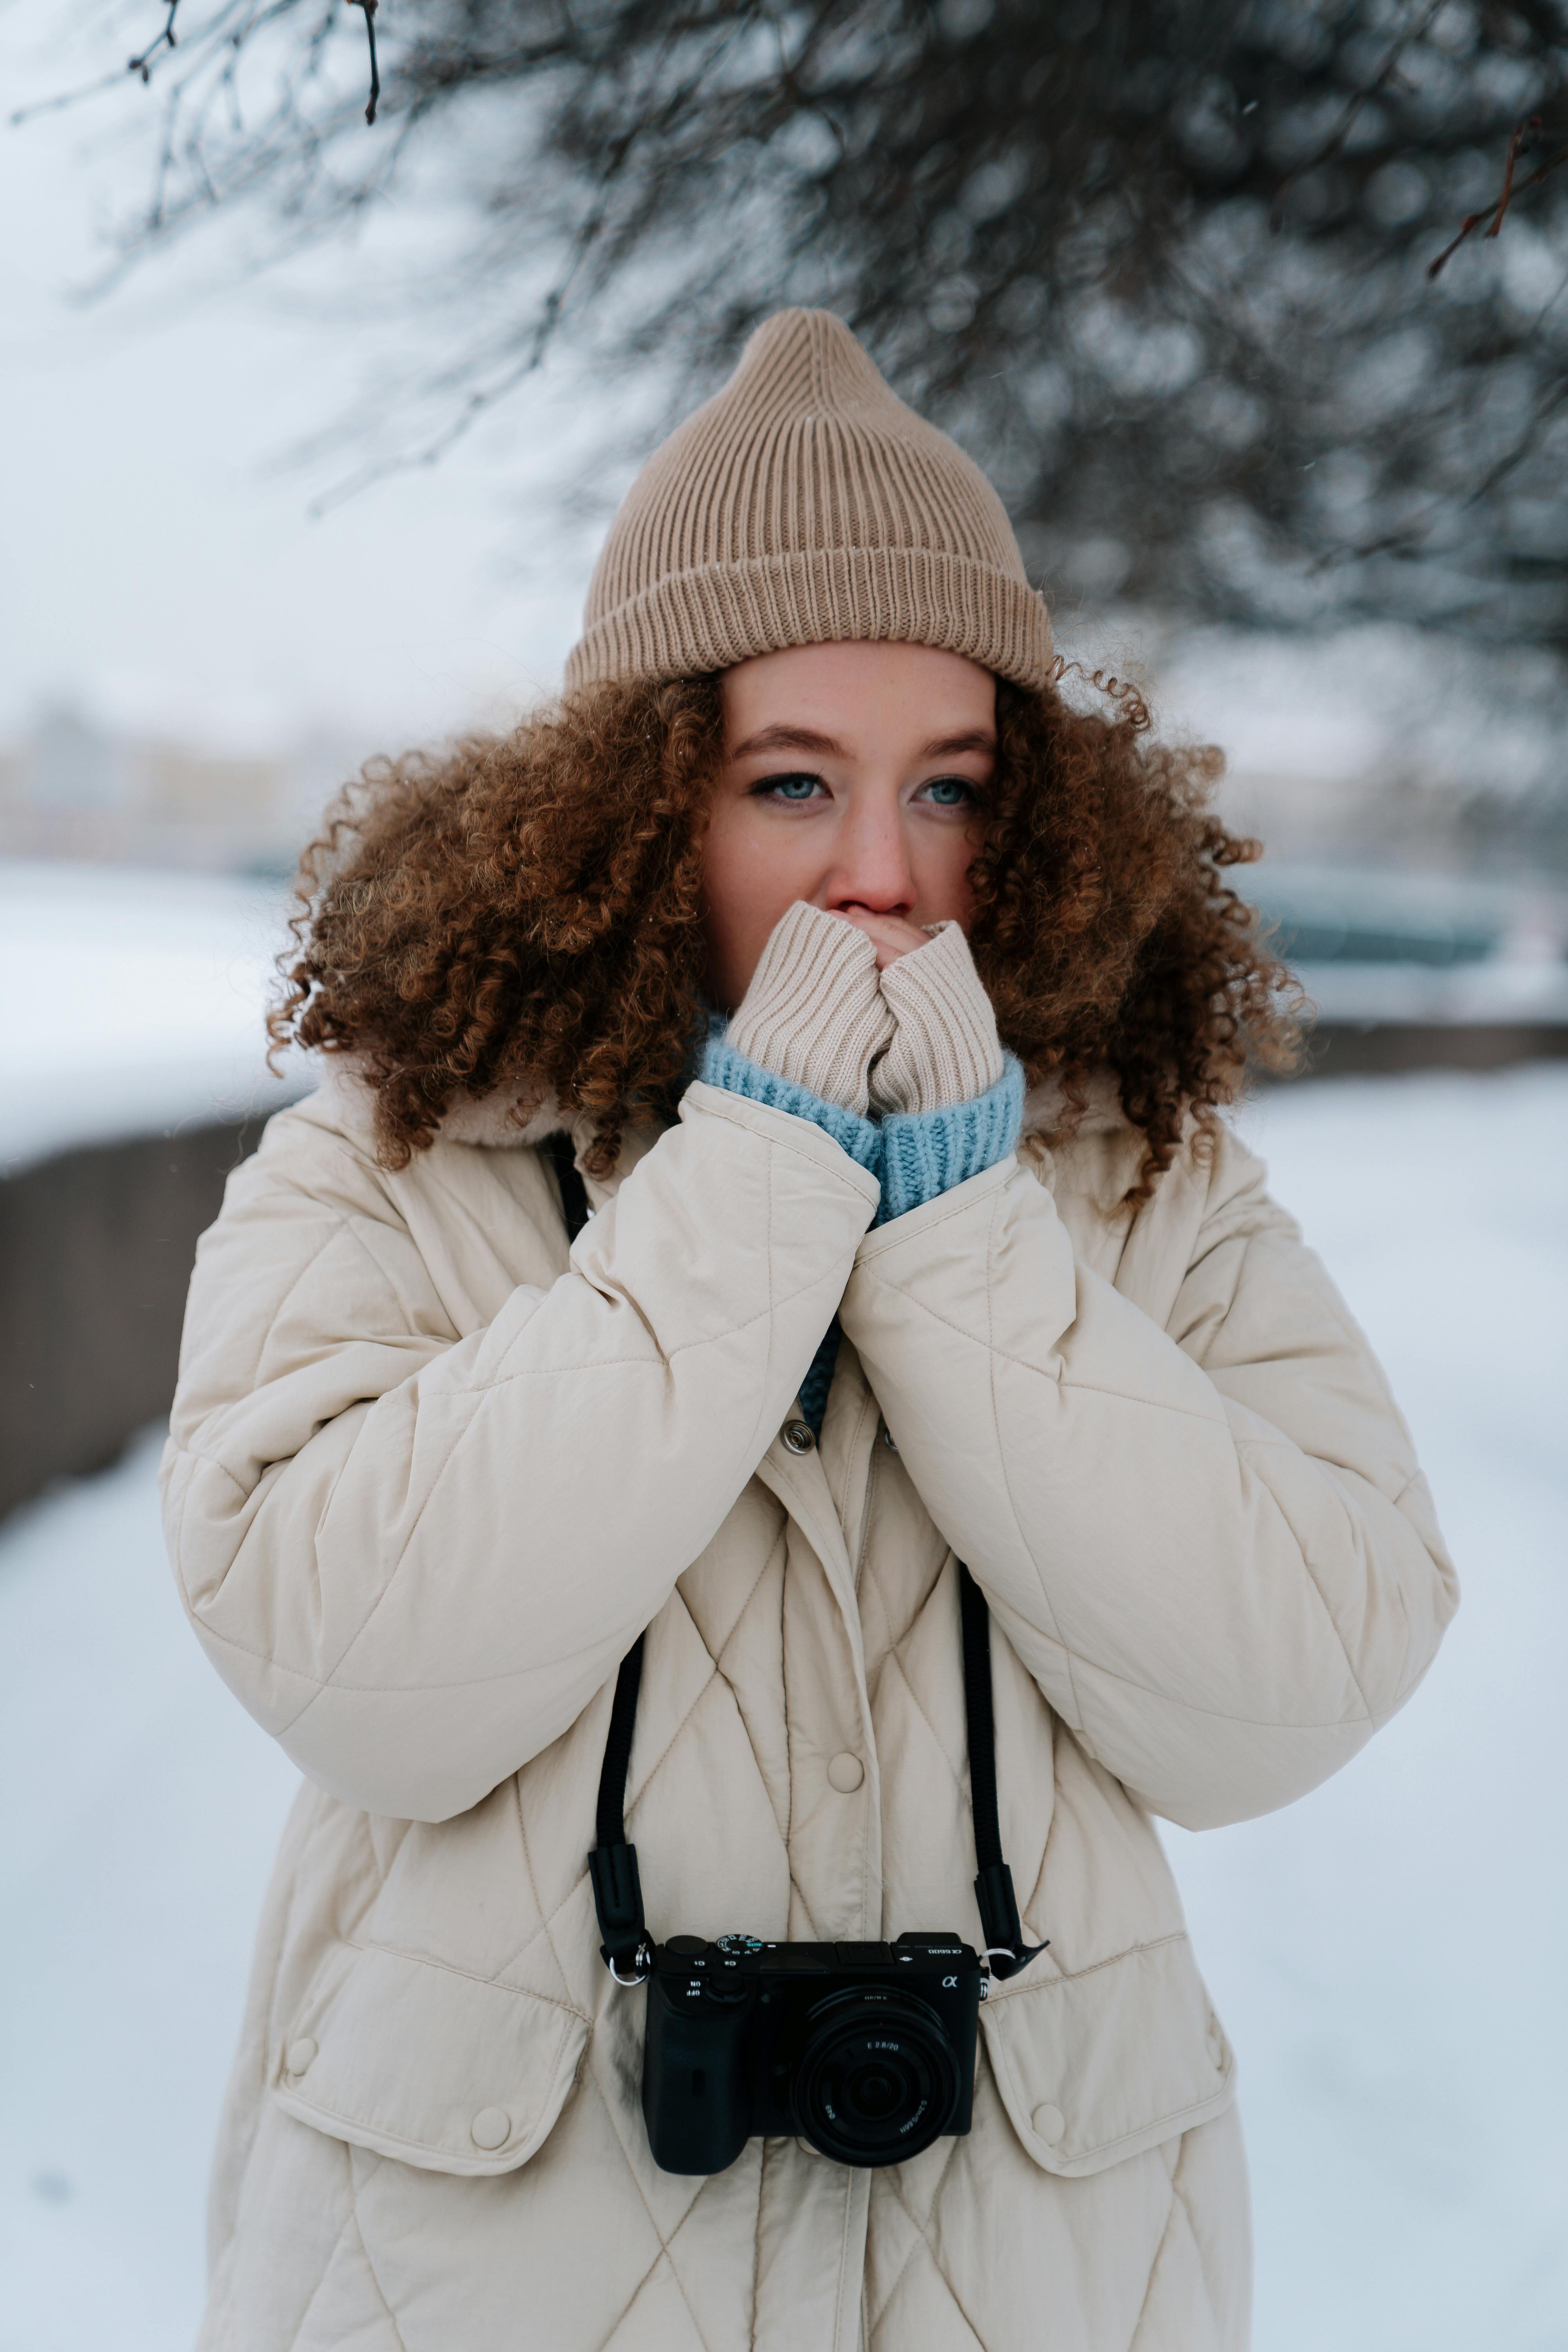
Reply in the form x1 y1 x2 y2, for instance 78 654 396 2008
703 644 997 1011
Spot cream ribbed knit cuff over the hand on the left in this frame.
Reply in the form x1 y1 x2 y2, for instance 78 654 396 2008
729 898 893 1117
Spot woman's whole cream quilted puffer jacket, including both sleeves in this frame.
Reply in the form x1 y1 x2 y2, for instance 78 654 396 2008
165 1084 1455 2352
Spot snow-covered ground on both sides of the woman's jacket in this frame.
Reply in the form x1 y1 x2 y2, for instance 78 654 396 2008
0 1070 1568 2352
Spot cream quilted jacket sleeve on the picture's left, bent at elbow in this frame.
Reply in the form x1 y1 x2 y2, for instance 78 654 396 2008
165 1084 877 1820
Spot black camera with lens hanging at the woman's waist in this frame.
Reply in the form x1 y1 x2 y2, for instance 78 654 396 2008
642 1933 985 2173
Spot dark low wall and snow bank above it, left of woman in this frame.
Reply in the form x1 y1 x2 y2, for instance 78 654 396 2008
0 861 315 1517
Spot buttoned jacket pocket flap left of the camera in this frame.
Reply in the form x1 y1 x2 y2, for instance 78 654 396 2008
273 1943 588 2173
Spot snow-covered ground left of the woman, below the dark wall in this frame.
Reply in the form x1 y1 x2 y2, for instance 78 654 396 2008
0 1437 296 2352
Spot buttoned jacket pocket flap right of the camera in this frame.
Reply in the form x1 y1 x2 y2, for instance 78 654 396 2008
980 1936 1236 2178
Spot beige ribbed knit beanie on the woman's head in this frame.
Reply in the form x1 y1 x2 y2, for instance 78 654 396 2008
566 310 1051 691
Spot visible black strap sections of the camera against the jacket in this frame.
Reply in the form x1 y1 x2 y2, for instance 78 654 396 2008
541 1134 1046 1983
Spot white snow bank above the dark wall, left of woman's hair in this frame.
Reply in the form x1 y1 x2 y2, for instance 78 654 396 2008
0 858 299 1176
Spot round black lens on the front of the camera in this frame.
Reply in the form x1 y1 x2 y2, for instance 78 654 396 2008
795 1987 959 2164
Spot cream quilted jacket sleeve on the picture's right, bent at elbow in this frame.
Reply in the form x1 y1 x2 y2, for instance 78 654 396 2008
842 1136 1457 1830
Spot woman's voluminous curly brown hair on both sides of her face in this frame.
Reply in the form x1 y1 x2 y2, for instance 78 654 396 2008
268 668 1298 1197
